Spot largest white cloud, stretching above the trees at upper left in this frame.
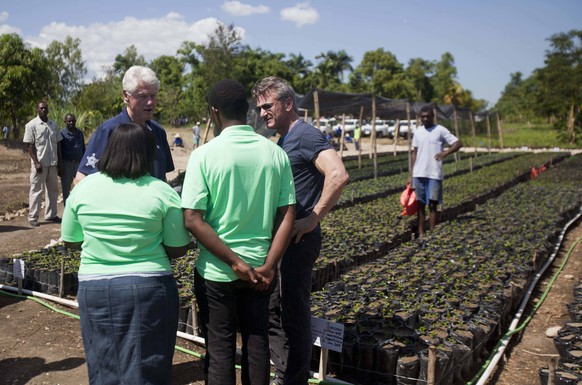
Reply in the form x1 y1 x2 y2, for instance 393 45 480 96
26 12 245 77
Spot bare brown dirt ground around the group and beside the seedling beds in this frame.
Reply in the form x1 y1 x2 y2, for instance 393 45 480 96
0 136 582 385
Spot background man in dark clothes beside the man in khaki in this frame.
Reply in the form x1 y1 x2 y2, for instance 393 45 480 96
61 114 85 204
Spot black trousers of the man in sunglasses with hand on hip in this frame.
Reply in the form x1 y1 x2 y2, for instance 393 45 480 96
269 227 321 385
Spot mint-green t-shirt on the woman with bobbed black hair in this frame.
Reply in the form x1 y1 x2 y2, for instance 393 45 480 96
61 173 190 275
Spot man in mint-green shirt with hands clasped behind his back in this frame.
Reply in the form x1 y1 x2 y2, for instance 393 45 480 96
182 79 295 385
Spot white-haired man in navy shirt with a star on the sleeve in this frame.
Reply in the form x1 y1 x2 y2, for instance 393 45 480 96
75 66 174 182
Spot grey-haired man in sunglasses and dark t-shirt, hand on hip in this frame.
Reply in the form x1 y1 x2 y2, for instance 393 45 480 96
252 77 349 385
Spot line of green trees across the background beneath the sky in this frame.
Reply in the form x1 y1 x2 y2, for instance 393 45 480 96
0 25 582 140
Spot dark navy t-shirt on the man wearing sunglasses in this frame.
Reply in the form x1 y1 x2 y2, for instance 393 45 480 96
279 120 333 219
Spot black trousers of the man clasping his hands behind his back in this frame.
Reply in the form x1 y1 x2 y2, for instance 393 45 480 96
194 270 274 385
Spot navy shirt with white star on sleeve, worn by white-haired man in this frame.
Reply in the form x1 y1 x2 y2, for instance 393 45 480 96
77 108 174 181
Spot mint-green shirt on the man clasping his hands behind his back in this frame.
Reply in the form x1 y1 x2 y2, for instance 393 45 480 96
182 125 295 282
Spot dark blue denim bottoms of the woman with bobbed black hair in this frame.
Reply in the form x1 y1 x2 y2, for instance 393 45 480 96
77 275 178 385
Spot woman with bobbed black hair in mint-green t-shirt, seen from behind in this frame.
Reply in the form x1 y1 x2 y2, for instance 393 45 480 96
61 123 190 384
